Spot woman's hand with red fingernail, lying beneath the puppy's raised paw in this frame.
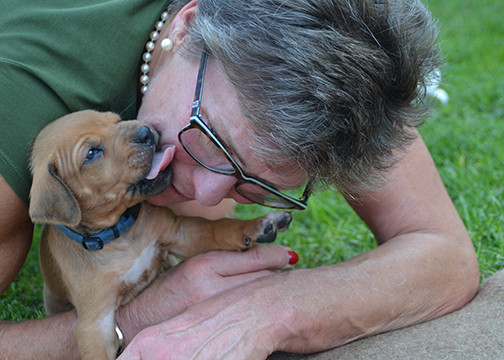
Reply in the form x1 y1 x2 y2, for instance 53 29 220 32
117 245 297 346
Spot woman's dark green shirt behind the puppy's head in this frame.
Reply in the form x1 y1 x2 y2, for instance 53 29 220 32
0 0 167 204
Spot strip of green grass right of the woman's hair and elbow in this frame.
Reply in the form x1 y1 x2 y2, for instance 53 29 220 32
422 0 504 279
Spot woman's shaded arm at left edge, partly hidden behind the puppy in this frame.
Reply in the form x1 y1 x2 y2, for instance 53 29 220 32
0 176 78 359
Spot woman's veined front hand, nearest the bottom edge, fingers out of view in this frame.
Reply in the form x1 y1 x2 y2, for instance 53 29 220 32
119 275 292 360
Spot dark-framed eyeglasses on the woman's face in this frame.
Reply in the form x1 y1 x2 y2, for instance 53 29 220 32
178 51 312 210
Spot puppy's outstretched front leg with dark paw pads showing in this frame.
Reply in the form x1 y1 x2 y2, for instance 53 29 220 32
163 211 292 259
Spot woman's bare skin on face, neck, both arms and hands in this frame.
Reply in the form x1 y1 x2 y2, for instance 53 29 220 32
0 1 479 360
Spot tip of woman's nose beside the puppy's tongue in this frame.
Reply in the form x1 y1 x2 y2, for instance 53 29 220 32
193 168 237 206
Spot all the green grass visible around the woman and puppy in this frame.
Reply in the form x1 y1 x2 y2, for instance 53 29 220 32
0 0 504 320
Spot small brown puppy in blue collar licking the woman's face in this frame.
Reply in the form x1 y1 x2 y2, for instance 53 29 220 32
30 111 291 360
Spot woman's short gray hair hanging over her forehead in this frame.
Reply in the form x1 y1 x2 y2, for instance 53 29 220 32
168 0 441 193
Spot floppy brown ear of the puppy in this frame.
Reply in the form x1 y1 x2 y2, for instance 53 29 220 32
29 164 81 226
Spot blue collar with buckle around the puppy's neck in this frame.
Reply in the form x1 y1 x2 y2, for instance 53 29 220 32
56 204 141 251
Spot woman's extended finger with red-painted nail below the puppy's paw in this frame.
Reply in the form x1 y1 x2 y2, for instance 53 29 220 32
200 245 298 276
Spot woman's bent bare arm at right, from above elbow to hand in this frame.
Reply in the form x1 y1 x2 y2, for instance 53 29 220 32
118 134 479 359
